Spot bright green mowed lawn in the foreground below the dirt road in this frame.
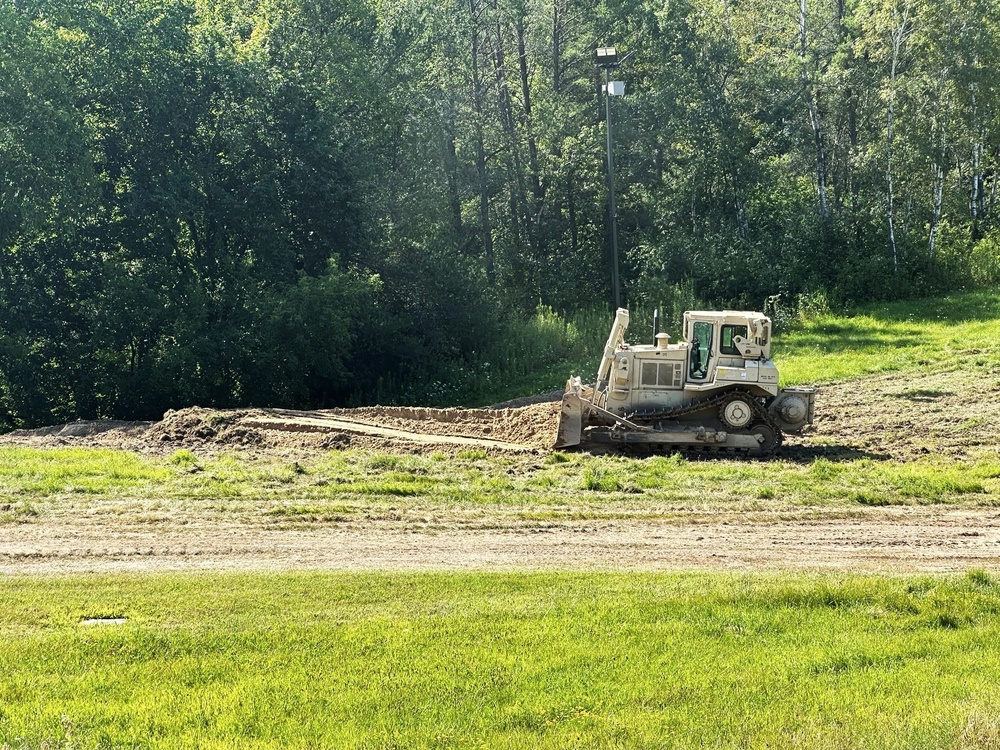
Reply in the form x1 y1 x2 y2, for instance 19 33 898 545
0 571 1000 748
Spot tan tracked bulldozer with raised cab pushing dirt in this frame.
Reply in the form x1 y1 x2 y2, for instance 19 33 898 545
554 309 816 456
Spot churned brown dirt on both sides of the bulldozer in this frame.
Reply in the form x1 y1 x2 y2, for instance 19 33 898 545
0 367 1000 460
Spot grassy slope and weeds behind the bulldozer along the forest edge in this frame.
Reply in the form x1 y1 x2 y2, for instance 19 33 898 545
472 289 1000 406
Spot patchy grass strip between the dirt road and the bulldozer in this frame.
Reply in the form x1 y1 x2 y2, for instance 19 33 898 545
0 447 1000 526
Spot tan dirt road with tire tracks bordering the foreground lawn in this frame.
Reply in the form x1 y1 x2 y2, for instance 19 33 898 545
0 506 1000 575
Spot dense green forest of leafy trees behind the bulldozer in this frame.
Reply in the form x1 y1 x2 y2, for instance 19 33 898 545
0 0 1000 428
